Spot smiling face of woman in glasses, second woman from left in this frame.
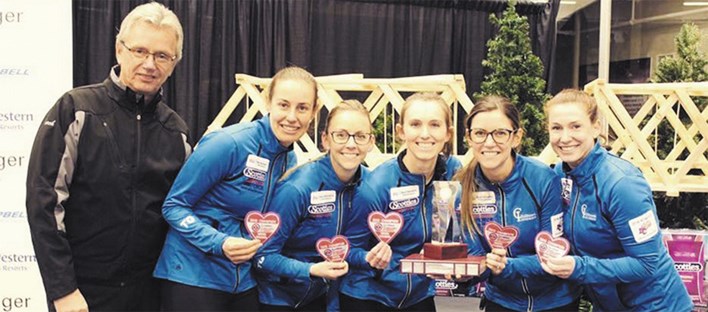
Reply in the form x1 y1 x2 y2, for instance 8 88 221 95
322 110 374 182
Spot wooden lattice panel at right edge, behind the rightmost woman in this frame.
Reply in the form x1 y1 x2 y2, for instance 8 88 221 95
585 79 708 196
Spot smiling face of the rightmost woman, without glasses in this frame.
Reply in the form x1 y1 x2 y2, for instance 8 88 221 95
546 102 600 168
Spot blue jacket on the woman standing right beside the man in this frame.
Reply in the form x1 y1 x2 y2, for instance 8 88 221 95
154 115 296 293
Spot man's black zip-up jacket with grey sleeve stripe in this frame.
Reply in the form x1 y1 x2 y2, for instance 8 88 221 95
26 69 191 300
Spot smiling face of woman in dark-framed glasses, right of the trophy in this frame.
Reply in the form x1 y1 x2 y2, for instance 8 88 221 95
466 109 522 182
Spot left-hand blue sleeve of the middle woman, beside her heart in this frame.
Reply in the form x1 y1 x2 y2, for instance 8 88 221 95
343 184 380 270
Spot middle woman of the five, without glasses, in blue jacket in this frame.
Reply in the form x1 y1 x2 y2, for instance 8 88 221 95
339 93 460 311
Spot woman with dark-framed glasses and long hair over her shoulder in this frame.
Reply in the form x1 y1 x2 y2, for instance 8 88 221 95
455 96 579 311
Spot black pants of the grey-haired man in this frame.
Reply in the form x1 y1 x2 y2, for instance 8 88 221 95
48 277 160 312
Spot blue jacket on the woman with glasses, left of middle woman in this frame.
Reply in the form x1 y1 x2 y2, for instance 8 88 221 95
253 154 368 308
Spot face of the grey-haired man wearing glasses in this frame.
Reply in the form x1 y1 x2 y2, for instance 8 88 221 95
116 22 177 99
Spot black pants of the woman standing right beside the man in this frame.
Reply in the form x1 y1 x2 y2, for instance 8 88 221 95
162 280 260 311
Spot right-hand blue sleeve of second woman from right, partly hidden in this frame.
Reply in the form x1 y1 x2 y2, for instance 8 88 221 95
501 172 563 278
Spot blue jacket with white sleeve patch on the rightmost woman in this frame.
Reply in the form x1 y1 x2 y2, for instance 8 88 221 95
555 143 692 311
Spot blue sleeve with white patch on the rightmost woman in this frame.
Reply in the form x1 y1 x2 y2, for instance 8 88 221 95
570 176 662 284
